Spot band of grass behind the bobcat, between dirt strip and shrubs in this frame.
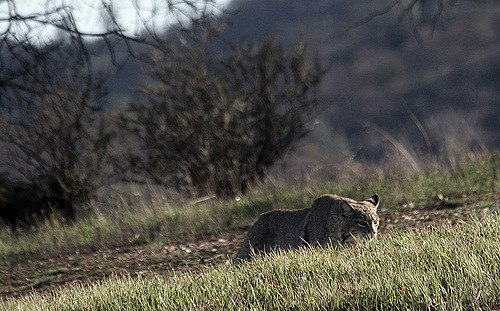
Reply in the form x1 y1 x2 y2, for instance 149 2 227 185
0 153 500 262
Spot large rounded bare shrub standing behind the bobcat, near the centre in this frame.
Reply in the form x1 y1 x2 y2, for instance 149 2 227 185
122 29 325 196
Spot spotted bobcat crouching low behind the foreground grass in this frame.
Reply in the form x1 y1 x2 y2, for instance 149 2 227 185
234 194 379 263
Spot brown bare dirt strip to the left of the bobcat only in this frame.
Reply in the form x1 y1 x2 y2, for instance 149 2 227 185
0 228 248 297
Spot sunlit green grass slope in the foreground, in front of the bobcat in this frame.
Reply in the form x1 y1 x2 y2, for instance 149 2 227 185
3 214 500 310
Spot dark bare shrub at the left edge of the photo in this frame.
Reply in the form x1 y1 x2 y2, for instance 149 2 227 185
0 51 113 229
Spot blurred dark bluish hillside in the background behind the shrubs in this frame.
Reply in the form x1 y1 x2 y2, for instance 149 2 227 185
89 0 500 176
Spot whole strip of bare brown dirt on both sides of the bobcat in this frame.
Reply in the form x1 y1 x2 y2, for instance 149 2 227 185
0 193 500 298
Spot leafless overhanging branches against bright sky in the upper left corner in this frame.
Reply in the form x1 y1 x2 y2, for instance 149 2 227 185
0 0 222 100
